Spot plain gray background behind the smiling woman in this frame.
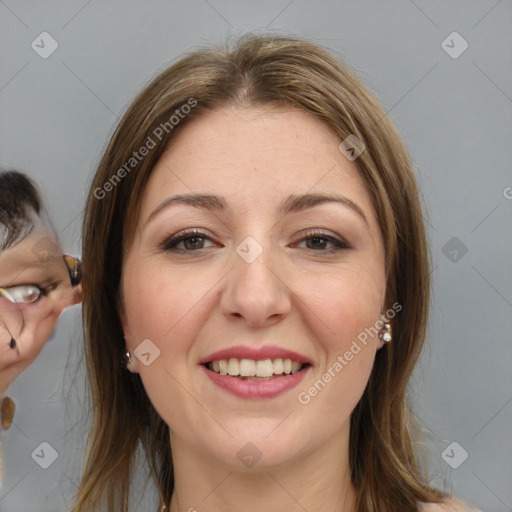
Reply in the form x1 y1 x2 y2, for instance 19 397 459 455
0 0 512 512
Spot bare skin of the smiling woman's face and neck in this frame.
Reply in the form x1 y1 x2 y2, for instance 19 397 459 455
120 108 386 512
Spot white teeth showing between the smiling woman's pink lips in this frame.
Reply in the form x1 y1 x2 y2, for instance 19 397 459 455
204 357 310 381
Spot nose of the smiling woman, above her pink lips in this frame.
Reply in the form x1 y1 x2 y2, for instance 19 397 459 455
221 240 292 327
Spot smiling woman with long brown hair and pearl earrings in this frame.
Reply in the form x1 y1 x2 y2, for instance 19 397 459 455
73 35 478 512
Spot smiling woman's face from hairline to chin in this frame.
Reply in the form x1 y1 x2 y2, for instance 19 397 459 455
121 108 385 469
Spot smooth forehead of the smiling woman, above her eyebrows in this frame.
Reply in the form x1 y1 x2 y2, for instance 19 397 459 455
141 107 373 227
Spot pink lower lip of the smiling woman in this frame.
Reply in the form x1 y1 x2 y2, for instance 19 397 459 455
202 365 311 398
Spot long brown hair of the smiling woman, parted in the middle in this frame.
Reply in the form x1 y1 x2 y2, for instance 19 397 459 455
72 34 445 512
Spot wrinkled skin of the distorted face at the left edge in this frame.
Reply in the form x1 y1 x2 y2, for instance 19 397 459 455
0 222 81 396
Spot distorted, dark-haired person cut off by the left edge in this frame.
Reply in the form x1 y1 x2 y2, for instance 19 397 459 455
0 171 81 476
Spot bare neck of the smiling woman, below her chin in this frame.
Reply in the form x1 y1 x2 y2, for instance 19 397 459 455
167 428 356 512
